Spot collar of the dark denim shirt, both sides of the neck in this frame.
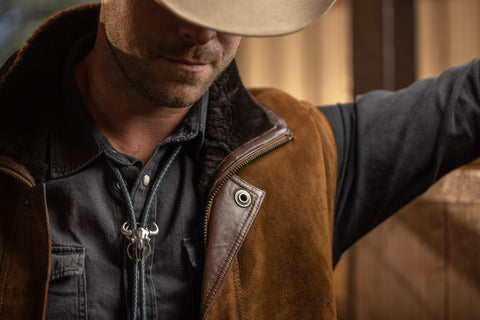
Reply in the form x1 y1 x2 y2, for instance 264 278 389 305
50 32 209 179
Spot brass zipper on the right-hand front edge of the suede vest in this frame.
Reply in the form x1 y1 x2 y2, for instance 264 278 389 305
203 134 293 250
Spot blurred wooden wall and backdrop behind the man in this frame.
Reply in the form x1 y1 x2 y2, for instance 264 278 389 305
0 0 480 320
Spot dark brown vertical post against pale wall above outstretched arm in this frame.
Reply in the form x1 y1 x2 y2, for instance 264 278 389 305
353 0 415 94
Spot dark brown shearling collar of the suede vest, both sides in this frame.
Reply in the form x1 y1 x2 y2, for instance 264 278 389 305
0 4 273 193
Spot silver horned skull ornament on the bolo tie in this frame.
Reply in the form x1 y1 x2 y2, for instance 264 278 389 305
122 222 158 261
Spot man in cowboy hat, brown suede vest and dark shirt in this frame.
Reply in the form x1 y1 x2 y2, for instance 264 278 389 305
0 0 480 319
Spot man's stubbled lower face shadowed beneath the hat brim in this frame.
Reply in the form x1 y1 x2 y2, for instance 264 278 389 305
101 0 241 108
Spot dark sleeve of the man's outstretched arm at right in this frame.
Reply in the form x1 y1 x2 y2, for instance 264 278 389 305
320 59 480 263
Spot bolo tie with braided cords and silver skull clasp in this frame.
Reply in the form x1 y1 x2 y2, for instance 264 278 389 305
107 145 182 320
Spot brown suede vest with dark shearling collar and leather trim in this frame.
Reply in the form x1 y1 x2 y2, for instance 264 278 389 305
0 5 337 319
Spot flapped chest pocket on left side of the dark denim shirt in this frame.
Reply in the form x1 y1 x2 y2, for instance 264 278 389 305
45 246 87 320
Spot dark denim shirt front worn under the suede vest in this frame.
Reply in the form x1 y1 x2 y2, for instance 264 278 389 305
46 34 208 319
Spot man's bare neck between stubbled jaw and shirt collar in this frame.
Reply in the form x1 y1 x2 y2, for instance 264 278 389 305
74 38 191 164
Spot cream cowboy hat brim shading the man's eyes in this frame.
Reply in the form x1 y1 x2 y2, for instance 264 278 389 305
155 0 335 36
